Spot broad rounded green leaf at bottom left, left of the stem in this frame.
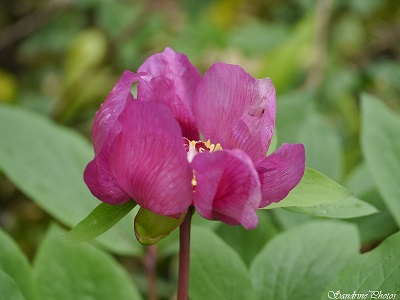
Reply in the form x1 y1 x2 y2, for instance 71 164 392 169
34 226 141 300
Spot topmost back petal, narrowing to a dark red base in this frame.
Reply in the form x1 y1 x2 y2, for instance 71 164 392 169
138 48 201 140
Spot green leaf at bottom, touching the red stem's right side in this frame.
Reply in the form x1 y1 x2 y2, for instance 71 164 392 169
190 226 254 300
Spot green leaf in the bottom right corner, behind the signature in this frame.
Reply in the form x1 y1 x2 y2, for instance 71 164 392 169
322 232 400 299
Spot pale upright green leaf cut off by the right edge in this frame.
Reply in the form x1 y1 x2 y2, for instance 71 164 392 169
361 95 400 226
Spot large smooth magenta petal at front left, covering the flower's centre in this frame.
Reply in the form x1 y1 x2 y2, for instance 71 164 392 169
110 101 193 216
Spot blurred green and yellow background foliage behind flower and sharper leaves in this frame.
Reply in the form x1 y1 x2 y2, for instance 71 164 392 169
0 0 400 294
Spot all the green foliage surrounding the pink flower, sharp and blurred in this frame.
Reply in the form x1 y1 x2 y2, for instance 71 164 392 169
0 0 400 300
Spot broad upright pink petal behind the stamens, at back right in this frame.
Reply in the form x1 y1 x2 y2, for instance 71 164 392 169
193 63 276 162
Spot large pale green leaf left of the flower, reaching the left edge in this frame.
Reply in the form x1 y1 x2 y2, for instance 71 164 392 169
0 105 140 254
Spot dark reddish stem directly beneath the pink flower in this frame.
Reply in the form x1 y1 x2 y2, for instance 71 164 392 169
177 207 194 300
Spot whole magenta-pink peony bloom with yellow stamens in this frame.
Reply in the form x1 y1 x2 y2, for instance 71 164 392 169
84 48 305 229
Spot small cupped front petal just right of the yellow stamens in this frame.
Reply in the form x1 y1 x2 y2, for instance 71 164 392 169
192 150 261 229
